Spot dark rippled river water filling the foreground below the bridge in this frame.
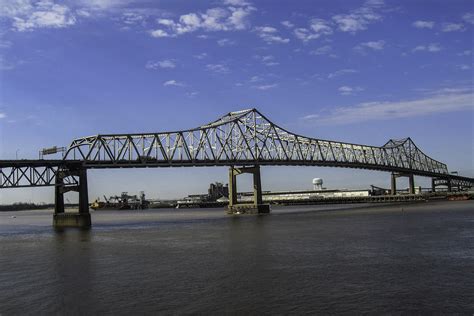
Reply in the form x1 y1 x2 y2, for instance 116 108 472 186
0 201 474 316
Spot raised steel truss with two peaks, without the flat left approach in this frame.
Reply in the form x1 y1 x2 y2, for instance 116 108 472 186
65 109 448 176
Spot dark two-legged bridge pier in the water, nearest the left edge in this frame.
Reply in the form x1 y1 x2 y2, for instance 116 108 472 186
53 168 91 228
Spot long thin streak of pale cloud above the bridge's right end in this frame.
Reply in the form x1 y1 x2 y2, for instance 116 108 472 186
304 89 474 125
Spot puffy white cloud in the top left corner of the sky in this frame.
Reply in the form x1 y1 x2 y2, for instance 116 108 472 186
4 0 76 32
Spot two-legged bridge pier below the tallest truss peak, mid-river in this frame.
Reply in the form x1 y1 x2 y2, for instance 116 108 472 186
227 165 270 214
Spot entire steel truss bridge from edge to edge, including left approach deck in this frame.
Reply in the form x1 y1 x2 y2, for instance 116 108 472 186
0 109 474 225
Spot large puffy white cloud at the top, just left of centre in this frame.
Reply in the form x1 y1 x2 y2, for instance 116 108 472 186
150 0 255 37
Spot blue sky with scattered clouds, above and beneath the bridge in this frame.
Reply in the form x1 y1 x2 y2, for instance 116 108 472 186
0 0 474 203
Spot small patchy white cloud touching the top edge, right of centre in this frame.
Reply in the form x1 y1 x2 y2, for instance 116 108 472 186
332 1 384 33
